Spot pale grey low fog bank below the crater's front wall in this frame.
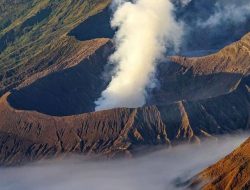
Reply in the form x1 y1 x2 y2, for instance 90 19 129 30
0 136 247 190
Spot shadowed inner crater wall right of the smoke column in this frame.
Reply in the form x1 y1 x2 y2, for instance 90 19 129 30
148 62 243 105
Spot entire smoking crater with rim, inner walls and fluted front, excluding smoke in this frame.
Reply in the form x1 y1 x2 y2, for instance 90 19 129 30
0 31 250 165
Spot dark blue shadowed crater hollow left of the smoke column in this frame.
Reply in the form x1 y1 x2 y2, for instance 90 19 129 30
8 47 111 116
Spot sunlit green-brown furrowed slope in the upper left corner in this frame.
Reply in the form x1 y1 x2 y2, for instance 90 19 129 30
0 0 110 95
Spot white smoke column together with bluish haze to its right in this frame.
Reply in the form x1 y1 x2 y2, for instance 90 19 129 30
95 0 250 110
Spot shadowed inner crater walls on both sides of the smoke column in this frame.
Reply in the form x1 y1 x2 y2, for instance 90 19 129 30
8 58 242 116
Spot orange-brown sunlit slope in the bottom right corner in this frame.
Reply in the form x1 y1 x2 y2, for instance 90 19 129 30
190 139 250 190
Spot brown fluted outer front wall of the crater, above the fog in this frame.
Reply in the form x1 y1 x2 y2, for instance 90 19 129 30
0 34 250 165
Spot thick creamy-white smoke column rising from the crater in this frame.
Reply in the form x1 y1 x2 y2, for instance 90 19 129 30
95 0 182 110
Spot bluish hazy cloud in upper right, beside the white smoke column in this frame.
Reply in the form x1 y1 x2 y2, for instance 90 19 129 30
176 0 250 52
